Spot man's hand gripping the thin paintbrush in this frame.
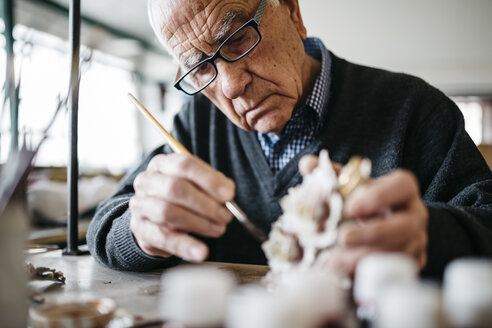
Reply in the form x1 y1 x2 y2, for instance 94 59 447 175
129 154 235 261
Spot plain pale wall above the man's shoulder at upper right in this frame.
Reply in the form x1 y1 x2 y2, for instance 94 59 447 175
299 0 492 95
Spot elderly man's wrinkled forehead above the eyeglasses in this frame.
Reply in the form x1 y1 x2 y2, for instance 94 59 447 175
149 0 257 68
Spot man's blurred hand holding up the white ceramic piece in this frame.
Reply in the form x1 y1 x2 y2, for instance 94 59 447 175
299 156 429 274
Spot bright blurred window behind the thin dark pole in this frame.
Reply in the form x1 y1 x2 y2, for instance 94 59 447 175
0 25 141 174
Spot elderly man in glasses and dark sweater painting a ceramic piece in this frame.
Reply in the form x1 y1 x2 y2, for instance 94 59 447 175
87 0 492 277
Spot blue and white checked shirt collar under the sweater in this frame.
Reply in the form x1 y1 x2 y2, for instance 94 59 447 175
257 38 331 173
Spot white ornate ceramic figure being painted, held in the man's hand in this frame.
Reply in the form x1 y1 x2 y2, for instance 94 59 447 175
262 150 370 280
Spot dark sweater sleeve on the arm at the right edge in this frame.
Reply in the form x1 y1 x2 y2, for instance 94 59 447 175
413 93 492 279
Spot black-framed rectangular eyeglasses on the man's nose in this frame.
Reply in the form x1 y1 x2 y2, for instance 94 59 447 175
174 0 268 96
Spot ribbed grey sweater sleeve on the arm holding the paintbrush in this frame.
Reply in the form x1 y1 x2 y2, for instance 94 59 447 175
87 105 194 271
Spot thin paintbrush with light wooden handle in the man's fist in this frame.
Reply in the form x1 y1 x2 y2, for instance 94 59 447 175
128 93 267 242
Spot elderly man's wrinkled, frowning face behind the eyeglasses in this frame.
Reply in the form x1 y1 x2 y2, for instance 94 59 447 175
152 0 312 134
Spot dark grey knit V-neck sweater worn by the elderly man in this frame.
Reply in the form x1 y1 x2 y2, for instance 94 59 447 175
87 55 492 278
